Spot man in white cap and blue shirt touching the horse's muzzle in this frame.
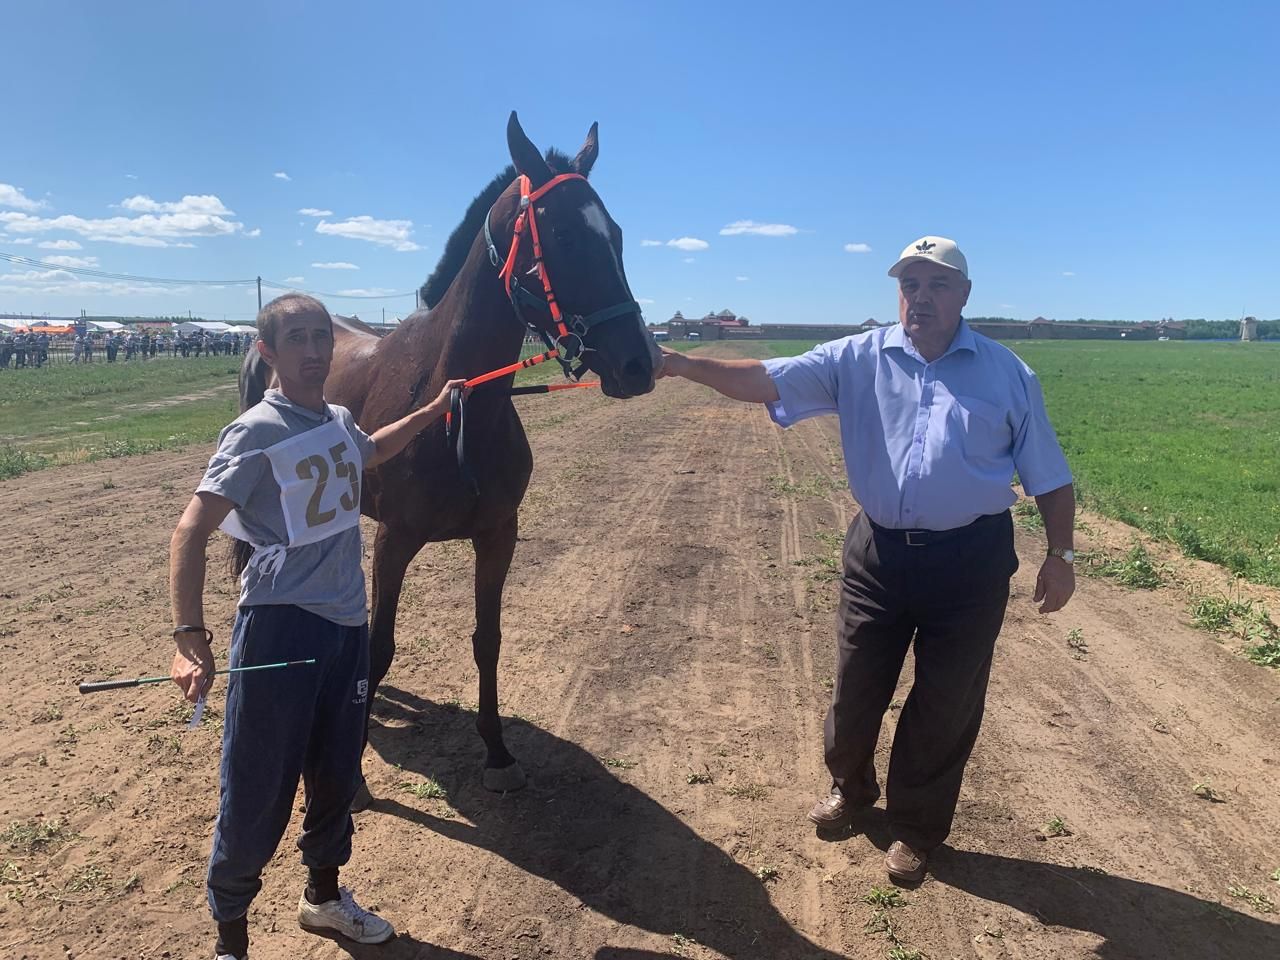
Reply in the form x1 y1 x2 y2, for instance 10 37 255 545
662 237 1075 883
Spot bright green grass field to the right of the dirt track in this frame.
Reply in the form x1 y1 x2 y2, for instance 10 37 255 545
751 340 1280 586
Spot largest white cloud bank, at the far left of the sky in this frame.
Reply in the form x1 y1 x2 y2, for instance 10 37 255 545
0 197 244 247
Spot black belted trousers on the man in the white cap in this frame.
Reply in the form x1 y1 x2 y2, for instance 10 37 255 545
826 511 1018 850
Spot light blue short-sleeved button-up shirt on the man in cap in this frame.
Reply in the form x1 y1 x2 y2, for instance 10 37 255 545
764 320 1071 530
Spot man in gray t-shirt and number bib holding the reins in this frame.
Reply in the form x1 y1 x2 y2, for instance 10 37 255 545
169 293 463 960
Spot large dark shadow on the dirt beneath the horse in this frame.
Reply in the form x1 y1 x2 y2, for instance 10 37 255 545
369 685 845 960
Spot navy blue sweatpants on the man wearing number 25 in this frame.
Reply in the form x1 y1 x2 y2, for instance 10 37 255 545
207 605 369 923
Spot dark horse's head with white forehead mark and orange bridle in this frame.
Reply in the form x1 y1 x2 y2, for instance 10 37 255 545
492 113 660 398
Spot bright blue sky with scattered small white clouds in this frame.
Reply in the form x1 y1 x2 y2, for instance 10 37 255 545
0 0 1280 323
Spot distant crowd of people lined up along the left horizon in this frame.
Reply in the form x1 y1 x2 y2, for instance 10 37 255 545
0 332 252 370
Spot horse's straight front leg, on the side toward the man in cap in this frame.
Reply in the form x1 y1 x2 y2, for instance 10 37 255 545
471 516 525 792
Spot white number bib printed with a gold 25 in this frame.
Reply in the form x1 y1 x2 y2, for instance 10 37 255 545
221 416 364 563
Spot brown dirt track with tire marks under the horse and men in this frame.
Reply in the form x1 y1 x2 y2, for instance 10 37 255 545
0 350 1280 960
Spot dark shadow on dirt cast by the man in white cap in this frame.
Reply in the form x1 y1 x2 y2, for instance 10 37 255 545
929 847 1280 960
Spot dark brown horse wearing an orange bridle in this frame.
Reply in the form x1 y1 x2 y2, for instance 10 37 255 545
241 113 659 791
